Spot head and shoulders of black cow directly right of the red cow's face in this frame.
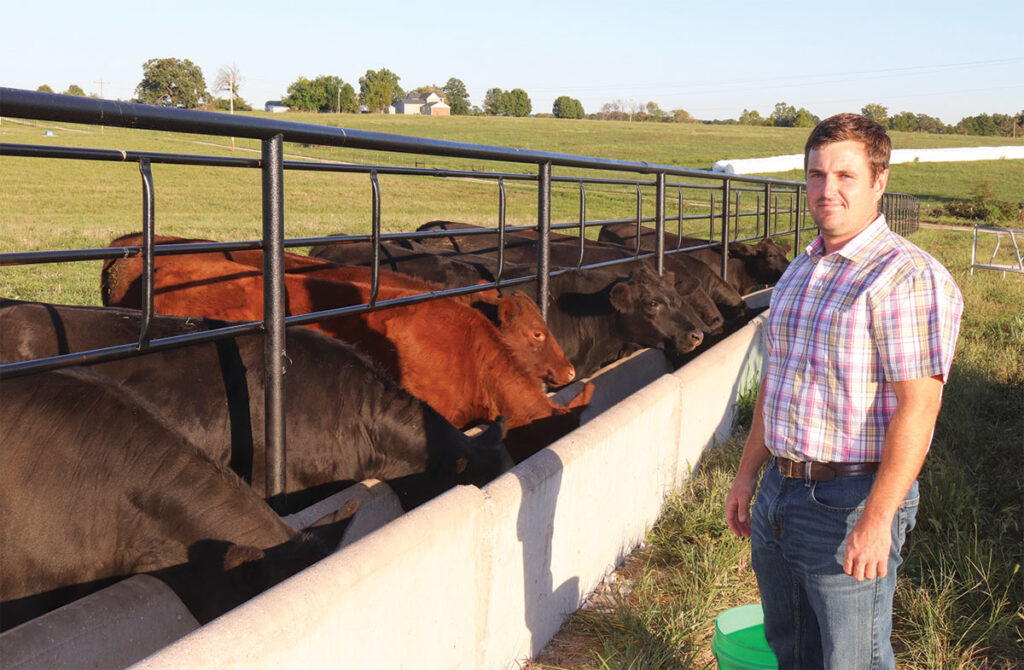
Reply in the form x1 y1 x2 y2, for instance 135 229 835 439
512 266 703 378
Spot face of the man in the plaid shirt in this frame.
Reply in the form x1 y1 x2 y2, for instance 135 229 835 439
807 139 889 253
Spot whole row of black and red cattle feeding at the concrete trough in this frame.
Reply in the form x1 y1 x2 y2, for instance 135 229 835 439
0 221 788 629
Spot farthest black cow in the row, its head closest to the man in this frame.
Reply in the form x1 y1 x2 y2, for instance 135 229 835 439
598 223 791 295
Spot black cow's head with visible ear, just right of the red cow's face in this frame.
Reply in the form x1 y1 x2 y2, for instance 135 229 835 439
609 267 703 354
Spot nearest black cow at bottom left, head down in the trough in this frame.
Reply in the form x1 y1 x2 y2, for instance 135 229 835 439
0 368 354 629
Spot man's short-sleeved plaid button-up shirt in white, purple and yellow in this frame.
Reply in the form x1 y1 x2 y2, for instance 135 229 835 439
764 215 964 462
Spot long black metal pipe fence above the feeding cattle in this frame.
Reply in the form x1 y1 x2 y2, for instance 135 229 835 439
0 88 920 510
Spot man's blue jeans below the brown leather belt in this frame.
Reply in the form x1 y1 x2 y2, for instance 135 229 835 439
751 460 919 670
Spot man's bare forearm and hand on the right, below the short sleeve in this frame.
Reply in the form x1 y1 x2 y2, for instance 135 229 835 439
843 375 942 581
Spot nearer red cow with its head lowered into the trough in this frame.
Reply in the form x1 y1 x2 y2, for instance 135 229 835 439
103 256 594 436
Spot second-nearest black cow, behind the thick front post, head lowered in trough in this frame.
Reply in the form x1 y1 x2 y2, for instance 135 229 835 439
0 300 511 507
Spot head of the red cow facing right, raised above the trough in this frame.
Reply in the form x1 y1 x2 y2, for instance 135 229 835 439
498 291 575 386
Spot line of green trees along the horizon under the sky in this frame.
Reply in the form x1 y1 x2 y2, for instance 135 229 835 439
29 58 1024 137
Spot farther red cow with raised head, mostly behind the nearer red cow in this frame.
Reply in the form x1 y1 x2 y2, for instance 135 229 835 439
100 233 575 386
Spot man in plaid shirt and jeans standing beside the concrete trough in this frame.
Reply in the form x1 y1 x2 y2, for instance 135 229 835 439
725 114 964 670
